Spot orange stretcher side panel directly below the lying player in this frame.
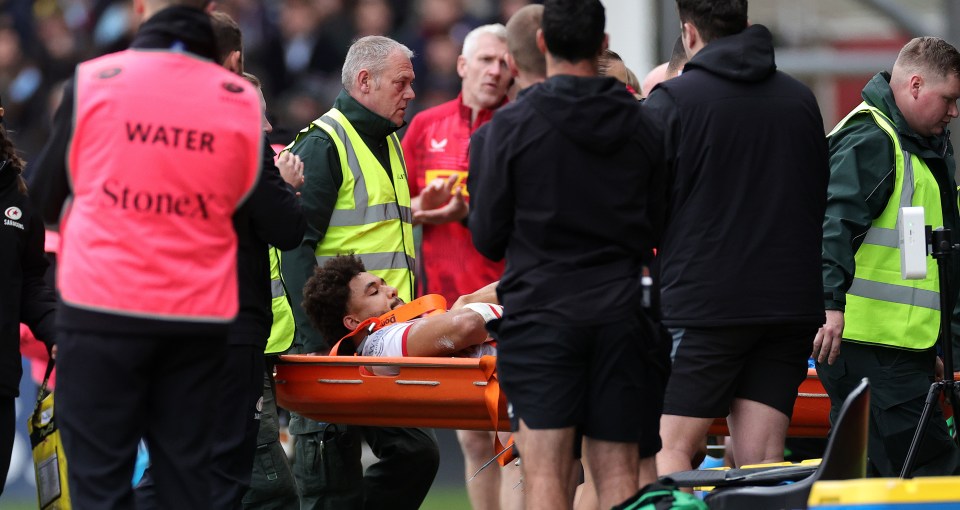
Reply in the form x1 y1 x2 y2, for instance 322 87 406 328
276 355 510 431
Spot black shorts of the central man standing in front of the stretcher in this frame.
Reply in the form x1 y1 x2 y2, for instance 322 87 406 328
491 315 670 457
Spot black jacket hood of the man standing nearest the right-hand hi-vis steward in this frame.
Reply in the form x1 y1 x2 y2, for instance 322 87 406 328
683 25 777 82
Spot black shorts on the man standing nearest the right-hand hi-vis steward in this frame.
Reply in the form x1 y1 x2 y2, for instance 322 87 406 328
663 324 817 418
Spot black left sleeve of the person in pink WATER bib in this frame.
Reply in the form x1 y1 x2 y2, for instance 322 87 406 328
30 80 74 225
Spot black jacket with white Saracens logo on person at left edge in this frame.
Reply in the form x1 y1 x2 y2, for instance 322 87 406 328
0 161 57 397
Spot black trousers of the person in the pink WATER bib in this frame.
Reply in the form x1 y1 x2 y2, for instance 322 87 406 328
55 331 226 510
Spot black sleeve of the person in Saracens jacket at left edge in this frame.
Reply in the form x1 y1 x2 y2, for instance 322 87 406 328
20 208 57 348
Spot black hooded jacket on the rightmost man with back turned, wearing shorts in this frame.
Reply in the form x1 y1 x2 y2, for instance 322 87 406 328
644 25 830 327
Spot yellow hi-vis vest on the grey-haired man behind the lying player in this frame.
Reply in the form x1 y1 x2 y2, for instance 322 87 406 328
313 108 415 303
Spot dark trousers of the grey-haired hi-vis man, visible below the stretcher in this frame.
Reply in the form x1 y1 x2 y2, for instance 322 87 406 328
293 424 440 510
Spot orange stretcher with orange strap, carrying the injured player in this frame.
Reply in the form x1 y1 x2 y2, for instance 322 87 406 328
276 295 830 437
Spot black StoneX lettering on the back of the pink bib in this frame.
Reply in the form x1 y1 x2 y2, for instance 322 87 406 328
101 179 216 220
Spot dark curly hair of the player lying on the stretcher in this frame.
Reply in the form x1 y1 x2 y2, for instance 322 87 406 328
303 255 366 346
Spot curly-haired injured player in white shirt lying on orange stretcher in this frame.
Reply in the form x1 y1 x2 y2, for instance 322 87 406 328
303 255 503 375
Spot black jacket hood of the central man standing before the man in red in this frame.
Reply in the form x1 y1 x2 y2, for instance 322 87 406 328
523 75 641 153
